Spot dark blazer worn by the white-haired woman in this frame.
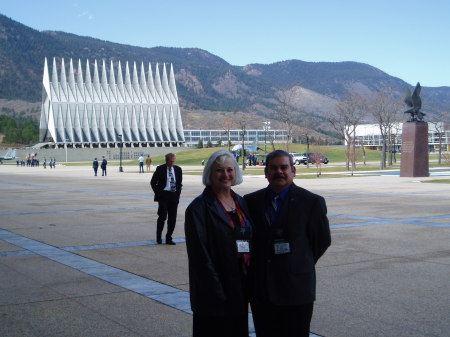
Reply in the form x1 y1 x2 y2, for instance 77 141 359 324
185 188 251 316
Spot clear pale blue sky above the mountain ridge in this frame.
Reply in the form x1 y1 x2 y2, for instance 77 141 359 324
0 0 450 87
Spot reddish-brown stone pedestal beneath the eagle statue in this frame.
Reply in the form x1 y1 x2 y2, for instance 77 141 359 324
400 122 430 177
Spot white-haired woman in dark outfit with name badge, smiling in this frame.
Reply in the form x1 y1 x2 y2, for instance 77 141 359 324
185 151 252 337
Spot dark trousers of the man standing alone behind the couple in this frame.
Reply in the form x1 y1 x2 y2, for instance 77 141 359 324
156 191 179 242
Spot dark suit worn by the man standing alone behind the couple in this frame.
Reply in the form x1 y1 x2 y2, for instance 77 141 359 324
150 164 183 243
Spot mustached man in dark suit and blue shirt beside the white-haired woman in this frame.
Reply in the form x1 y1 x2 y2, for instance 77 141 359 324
244 150 331 337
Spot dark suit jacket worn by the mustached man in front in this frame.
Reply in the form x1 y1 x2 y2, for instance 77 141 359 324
244 184 331 305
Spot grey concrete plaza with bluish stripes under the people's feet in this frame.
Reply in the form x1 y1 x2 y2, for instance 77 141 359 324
0 165 450 337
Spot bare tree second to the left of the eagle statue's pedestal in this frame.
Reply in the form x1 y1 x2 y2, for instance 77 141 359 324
328 92 366 175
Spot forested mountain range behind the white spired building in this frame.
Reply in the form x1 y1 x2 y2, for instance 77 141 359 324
0 14 450 134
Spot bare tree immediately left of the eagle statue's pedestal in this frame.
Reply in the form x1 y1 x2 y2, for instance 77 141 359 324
370 90 402 169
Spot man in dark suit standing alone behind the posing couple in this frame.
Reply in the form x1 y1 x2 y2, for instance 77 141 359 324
150 153 183 245
